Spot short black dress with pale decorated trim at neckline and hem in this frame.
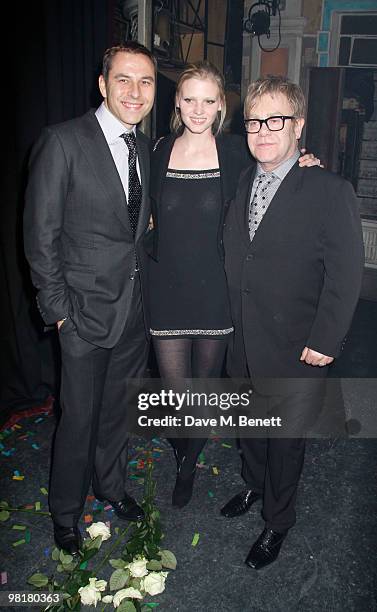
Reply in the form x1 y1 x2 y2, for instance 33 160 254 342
149 168 233 338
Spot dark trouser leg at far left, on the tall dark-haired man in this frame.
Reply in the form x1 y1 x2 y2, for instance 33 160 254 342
49 322 110 527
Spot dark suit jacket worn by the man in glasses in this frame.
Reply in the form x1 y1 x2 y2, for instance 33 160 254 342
224 164 364 377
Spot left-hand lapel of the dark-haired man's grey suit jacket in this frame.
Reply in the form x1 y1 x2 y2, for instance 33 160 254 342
77 111 131 232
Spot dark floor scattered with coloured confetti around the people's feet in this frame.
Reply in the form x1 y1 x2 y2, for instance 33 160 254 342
0 300 377 612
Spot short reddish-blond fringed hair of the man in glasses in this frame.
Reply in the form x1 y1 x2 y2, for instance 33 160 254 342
243 76 306 119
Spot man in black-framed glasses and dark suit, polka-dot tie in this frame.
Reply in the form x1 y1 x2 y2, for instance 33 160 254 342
221 77 364 569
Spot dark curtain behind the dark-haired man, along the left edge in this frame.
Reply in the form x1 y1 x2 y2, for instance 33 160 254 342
0 0 115 422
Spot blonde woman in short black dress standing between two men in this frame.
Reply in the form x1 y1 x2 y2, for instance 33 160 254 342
145 61 319 507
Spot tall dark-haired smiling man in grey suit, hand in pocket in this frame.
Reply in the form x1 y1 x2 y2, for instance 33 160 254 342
24 42 156 554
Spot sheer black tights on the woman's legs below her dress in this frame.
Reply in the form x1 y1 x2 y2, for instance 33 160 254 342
153 336 228 473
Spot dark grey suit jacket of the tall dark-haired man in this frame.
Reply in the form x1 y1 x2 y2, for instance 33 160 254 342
24 110 150 348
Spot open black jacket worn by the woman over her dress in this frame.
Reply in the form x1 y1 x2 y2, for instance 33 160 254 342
145 134 253 260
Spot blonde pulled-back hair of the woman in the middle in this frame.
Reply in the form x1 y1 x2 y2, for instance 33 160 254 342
170 60 226 136
